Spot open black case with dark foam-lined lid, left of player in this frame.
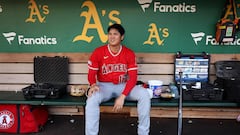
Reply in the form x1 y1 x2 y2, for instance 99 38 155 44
22 56 69 99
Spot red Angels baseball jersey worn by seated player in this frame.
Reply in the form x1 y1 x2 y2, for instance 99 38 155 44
88 45 137 95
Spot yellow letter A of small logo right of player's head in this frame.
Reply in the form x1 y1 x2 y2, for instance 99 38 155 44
143 23 164 45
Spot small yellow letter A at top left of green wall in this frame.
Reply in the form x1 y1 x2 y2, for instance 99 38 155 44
25 0 45 23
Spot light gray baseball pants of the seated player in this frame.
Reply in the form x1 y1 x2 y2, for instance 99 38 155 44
85 82 151 135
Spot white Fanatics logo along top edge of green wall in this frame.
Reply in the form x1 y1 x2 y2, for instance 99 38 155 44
137 0 197 13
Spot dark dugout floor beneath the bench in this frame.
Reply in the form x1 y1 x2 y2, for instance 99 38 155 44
0 114 240 135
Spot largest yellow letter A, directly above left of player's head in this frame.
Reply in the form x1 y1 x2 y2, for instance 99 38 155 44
73 1 107 43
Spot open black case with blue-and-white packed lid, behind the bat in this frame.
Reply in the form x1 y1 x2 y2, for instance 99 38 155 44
174 52 223 100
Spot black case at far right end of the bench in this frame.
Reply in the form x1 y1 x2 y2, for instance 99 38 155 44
215 60 240 102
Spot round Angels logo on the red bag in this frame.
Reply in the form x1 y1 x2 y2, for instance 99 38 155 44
0 110 14 129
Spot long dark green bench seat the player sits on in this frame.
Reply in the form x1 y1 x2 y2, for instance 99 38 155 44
0 91 240 107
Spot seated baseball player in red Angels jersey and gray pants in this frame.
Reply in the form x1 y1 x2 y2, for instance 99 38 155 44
85 24 151 135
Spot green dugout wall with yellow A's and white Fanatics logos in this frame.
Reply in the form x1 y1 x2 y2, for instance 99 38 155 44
0 0 240 53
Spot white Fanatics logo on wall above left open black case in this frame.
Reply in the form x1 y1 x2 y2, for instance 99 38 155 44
2 32 57 45
